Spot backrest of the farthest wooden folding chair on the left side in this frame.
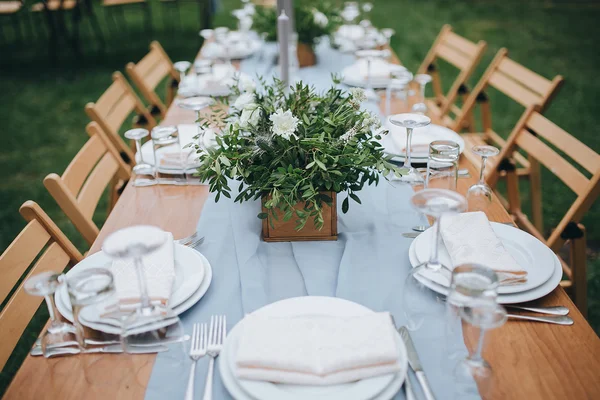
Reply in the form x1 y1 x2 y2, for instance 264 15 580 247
125 41 179 117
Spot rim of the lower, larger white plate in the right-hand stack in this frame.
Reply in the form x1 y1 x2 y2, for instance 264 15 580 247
408 234 562 304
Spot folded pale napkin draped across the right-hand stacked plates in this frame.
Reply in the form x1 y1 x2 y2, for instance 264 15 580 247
440 211 527 285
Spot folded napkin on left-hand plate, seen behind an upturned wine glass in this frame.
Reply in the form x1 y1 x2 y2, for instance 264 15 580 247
110 232 175 305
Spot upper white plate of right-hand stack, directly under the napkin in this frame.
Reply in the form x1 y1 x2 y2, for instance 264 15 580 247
414 222 554 294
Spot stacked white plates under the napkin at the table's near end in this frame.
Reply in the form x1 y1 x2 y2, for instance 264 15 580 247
218 296 408 400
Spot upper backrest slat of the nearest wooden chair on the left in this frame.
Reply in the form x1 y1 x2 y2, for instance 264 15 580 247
0 220 50 304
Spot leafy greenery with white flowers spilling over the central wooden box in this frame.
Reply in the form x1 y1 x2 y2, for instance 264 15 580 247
198 77 399 242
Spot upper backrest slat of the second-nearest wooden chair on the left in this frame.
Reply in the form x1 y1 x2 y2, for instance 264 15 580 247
62 136 106 194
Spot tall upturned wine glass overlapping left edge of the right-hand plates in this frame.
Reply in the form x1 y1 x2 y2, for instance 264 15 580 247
402 189 467 334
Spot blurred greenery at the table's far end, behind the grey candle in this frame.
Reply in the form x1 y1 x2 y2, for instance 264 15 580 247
252 0 342 47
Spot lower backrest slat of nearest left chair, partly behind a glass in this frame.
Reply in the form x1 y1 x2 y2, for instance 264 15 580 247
0 242 70 369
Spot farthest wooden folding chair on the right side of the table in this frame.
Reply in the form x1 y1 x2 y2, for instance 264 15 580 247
417 25 487 128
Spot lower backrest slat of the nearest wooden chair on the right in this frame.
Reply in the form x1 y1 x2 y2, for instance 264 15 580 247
516 130 589 195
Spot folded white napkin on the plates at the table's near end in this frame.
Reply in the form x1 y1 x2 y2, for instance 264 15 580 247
236 313 401 385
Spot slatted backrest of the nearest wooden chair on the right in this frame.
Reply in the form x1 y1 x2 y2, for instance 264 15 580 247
487 106 600 251
